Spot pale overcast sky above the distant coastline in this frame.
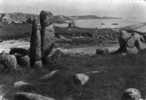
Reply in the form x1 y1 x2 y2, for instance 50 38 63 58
0 0 146 18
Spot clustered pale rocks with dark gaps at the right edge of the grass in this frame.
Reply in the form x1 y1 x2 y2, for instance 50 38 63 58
115 30 146 54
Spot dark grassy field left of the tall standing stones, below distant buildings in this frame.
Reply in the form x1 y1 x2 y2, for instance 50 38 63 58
0 23 31 40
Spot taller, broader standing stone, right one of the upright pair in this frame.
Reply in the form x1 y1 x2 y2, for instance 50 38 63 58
40 11 55 63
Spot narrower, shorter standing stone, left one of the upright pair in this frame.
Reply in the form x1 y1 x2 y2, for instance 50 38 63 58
30 20 42 68
